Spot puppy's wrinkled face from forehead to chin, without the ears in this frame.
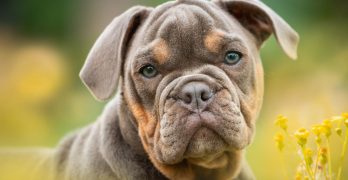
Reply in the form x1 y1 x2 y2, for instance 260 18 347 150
123 4 263 168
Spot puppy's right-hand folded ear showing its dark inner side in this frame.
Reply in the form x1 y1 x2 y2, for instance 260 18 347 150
213 0 299 59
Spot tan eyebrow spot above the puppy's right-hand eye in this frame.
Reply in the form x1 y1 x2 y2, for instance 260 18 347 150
204 31 223 53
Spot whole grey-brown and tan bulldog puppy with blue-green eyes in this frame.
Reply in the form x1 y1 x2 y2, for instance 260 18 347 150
53 0 299 180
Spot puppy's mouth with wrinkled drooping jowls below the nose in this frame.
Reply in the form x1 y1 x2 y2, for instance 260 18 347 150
155 104 247 165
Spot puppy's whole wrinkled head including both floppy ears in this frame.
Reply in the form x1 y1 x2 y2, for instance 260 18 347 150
80 0 298 179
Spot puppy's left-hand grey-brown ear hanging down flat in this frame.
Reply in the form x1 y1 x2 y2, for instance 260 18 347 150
80 6 152 101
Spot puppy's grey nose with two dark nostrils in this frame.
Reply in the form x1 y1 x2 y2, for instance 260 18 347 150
179 82 213 110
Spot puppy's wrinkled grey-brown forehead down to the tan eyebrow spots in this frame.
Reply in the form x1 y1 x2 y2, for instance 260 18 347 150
130 1 250 63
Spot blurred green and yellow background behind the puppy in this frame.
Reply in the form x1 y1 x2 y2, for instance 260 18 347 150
0 0 348 179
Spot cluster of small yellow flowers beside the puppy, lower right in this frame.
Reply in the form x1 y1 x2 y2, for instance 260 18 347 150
274 113 348 180
